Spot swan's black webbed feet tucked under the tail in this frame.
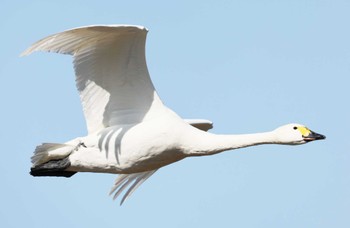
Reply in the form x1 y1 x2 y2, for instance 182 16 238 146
30 157 76 177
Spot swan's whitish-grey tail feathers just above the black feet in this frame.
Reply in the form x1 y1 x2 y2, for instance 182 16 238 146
31 143 76 167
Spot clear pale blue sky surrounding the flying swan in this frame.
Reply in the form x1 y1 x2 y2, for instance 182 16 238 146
0 0 350 228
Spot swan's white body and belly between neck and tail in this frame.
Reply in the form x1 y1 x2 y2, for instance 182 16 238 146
69 119 190 173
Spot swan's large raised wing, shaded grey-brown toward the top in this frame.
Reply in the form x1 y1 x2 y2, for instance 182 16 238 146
22 25 163 133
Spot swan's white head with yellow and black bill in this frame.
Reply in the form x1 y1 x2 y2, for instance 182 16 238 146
274 124 326 145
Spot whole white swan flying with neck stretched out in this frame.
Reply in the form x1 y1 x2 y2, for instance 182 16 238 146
22 25 325 204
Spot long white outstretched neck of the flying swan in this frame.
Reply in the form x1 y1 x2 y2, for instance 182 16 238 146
183 131 280 156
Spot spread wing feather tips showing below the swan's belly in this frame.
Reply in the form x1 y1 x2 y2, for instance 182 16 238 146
109 170 157 205
